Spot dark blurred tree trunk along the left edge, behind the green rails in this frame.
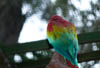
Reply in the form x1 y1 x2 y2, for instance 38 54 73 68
0 0 25 68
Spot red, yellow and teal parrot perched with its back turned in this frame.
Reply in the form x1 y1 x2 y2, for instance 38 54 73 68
47 15 79 68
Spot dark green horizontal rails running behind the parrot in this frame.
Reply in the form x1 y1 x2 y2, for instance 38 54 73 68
0 32 100 68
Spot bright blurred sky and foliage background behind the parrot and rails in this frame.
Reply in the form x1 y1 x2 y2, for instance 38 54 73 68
14 0 100 68
